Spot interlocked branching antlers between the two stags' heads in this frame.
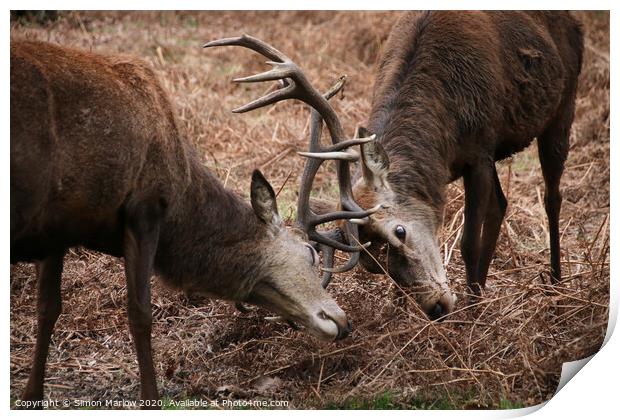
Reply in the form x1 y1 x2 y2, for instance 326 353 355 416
203 35 381 285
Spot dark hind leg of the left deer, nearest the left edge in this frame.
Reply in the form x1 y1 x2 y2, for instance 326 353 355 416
22 250 65 408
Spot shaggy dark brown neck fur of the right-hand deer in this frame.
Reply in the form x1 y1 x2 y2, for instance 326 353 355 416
369 12 506 220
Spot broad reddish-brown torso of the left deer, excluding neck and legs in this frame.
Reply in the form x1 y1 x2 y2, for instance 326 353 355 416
11 41 186 259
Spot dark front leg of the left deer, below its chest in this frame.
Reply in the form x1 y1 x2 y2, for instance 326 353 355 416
123 208 159 408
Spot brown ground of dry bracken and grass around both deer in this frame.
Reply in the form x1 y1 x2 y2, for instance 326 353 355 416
11 12 609 408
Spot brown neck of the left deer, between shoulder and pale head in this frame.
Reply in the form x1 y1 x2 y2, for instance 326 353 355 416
155 159 265 300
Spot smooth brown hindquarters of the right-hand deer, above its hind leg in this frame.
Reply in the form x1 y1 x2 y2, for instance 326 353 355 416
493 11 583 160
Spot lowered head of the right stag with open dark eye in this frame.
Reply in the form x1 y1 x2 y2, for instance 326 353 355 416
344 128 456 319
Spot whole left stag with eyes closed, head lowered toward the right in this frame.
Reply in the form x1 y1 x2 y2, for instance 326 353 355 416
10 41 370 401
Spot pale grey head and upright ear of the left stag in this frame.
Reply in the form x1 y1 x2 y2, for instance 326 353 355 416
245 170 351 340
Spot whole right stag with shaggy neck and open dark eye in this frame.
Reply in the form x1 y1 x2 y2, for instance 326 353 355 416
320 11 583 317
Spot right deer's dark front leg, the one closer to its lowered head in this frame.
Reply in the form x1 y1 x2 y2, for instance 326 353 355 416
461 161 493 296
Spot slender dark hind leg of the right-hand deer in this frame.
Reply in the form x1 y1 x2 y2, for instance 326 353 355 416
538 116 573 284
